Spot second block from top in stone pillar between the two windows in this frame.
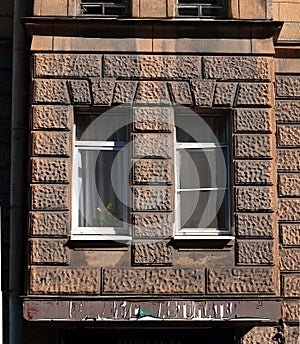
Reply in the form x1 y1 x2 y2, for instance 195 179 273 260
133 134 173 159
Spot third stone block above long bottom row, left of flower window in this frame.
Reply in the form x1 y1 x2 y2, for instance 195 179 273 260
31 184 69 210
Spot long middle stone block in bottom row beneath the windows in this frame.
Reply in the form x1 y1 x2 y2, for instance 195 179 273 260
102 268 205 294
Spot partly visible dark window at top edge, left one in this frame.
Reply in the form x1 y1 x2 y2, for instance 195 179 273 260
80 0 128 17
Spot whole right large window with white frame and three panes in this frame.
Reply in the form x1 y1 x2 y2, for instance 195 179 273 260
175 113 230 236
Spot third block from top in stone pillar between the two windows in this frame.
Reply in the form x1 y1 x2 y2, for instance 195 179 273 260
133 160 172 184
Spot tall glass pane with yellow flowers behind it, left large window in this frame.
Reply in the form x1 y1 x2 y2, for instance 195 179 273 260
78 150 127 227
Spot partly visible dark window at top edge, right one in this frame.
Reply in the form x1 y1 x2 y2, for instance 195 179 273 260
176 0 225 18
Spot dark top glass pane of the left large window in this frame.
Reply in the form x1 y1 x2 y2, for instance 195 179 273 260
75 113 129 142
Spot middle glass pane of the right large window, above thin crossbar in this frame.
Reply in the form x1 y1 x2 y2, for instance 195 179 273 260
179 148 227 189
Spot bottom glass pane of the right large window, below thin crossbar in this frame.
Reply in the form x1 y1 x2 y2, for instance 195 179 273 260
179 191 228 229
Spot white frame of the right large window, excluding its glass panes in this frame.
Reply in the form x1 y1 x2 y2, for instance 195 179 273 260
174 114 234 240
